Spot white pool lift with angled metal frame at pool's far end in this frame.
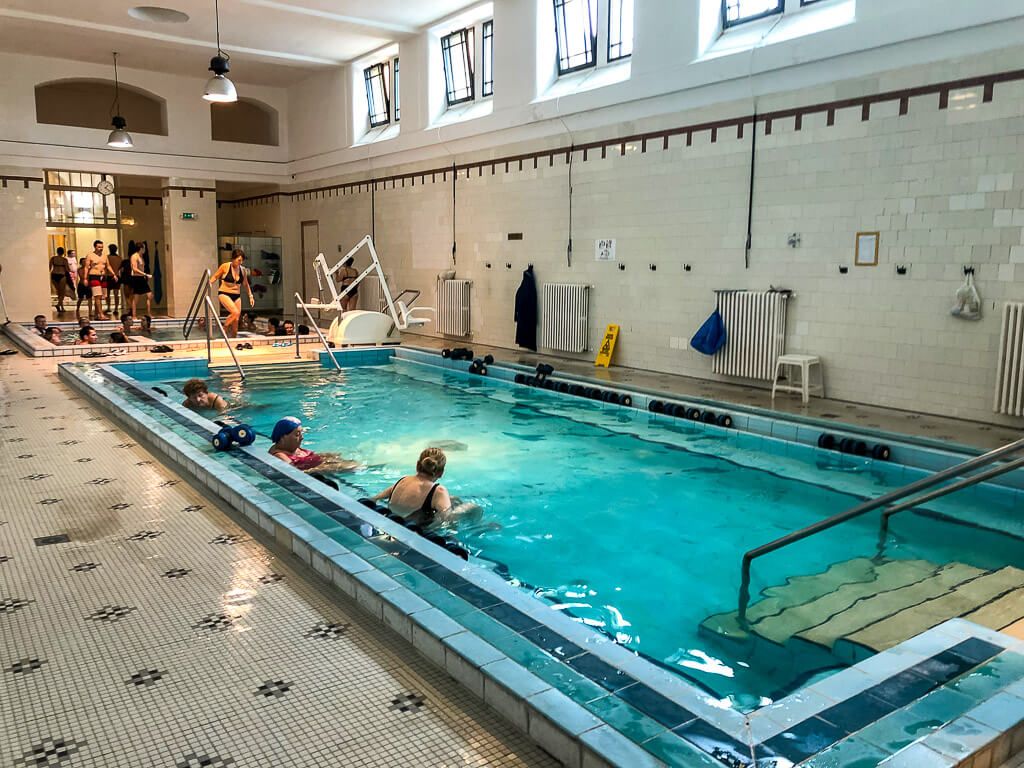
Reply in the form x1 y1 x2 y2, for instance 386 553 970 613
298 234 434 347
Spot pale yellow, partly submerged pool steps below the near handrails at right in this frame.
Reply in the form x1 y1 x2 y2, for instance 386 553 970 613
700 557 1024 664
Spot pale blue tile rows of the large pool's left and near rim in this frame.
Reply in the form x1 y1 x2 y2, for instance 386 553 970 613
58 360 1024 765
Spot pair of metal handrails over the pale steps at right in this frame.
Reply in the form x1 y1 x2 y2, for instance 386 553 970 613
739 438 1024 626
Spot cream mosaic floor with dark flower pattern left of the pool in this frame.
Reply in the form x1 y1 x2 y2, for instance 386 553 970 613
0 350 556 768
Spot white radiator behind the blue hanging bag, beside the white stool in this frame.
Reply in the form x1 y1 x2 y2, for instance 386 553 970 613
713 291 788 381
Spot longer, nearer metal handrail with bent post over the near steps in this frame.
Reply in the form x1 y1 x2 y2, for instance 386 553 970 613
739 438 1024 624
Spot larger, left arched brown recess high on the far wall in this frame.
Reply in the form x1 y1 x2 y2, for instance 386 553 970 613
36 79 167 136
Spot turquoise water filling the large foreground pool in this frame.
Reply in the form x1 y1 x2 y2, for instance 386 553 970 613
163 360 1013 709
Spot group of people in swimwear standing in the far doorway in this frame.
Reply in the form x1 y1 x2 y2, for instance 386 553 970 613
49 240 153 321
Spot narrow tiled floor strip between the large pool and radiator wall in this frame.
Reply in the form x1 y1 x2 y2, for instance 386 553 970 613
402 333 1020 450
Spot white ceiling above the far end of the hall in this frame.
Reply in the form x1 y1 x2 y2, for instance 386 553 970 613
0 0 467 86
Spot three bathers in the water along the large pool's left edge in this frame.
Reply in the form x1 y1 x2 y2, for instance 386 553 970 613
181 379 458 527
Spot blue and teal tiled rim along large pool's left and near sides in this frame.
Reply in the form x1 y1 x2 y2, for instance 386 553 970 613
59 360 1024 767
